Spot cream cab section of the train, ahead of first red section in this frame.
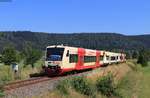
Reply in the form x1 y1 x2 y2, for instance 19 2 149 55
43 45 78 75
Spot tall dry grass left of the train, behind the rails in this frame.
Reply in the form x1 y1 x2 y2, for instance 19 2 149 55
0 58 44 82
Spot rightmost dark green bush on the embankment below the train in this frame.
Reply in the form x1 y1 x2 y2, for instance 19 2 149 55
96 74 118 97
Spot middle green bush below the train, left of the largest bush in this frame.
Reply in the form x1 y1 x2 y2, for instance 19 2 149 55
71 76 93 96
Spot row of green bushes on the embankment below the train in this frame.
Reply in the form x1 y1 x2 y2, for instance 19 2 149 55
57 74 121 98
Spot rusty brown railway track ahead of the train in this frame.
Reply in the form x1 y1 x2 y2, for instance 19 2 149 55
4 77 60 91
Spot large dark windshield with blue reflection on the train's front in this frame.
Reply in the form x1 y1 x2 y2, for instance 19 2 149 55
46 48 64 61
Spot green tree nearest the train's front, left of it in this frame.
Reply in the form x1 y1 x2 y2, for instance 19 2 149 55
22 43 42 68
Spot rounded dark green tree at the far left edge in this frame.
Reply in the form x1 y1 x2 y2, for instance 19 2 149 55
1 46 17 65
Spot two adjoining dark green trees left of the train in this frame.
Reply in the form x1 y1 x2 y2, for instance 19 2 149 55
0 43 43 68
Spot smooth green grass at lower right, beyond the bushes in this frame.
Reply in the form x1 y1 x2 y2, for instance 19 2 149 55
119 61 150 98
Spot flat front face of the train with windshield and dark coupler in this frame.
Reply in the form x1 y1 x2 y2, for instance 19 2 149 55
43 46 65 76
